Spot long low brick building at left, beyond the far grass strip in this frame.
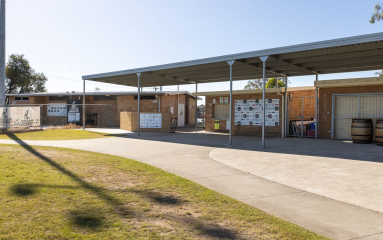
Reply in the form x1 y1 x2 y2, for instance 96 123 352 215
7 91 196 127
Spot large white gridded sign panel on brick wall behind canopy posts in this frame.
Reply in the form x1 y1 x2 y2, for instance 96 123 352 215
234 99 279 126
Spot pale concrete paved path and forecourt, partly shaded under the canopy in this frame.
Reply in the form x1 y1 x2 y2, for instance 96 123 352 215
0 132 383 239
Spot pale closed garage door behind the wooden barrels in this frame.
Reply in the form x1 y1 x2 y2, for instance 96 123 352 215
332 94 383 139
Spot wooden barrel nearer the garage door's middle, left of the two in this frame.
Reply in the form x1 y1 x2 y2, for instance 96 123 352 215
351 119 373 143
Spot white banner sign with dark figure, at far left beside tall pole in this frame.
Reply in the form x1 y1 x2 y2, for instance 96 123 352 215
0 107 40 128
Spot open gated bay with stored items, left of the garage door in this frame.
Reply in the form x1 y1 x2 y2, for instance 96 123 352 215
287 96 316 138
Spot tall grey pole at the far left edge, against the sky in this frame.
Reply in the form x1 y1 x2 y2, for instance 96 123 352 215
0 0 5 105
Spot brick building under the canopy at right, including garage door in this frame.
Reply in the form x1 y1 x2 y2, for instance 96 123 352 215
198 77 383 139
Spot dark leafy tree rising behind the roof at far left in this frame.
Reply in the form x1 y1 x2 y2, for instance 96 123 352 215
5 54 48 103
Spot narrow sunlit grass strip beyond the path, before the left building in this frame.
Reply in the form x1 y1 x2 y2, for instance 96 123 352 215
0 129 113 140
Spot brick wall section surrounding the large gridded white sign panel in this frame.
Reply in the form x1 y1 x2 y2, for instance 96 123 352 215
205 93 283 137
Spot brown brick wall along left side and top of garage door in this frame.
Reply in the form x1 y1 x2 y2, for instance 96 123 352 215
319 85 383 138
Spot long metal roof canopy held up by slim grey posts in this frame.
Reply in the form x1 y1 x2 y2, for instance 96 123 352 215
82 33 383 87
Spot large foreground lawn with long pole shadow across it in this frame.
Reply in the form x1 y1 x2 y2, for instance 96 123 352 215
0 143 326 239
